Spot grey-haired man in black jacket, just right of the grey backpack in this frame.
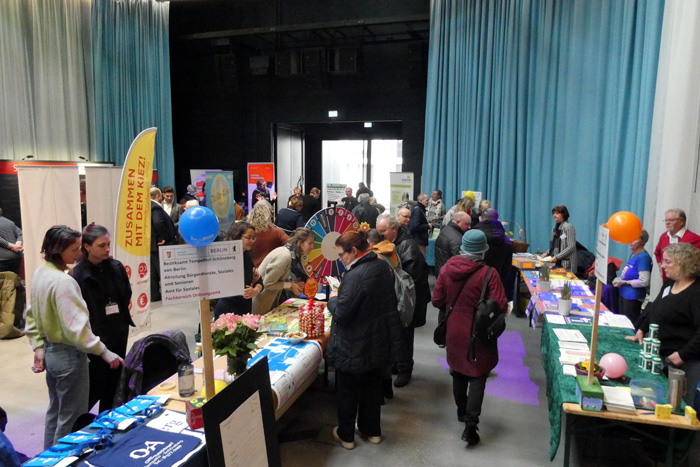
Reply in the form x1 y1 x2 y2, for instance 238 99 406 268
377 214 430 388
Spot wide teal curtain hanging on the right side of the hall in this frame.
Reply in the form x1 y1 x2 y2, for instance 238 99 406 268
422 0 664 258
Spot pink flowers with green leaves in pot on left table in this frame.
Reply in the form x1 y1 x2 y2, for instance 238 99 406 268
211 313 262 377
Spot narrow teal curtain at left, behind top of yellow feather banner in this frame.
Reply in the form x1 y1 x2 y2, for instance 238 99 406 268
92 0 175 186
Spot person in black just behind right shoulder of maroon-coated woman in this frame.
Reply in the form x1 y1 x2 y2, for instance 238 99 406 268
473 208 515 297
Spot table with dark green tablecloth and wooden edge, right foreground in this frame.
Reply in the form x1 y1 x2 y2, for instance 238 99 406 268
541 318 700 465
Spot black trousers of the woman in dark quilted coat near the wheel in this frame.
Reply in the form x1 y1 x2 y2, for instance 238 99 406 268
335 368 384 443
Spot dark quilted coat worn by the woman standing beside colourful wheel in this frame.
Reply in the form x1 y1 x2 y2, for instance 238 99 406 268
326 251 407 374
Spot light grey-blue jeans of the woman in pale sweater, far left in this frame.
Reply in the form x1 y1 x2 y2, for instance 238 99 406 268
44 342 90 449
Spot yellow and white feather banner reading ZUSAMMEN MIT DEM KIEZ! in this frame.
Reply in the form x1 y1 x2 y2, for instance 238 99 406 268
114 128 156 334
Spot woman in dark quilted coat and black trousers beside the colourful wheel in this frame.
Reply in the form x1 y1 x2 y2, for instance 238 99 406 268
326 232 406 449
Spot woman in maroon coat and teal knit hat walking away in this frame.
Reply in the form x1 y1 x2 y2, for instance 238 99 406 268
433 230 507 446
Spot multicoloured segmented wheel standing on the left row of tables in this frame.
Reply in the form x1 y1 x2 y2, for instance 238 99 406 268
302 208 360 284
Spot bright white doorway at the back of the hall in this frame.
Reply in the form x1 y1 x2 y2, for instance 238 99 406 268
322 139 403 208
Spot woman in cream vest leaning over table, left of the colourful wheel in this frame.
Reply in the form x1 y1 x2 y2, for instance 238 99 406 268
253 228 314 315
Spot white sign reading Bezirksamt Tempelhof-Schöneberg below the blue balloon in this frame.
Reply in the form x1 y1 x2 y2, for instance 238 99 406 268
160 240 245 305
